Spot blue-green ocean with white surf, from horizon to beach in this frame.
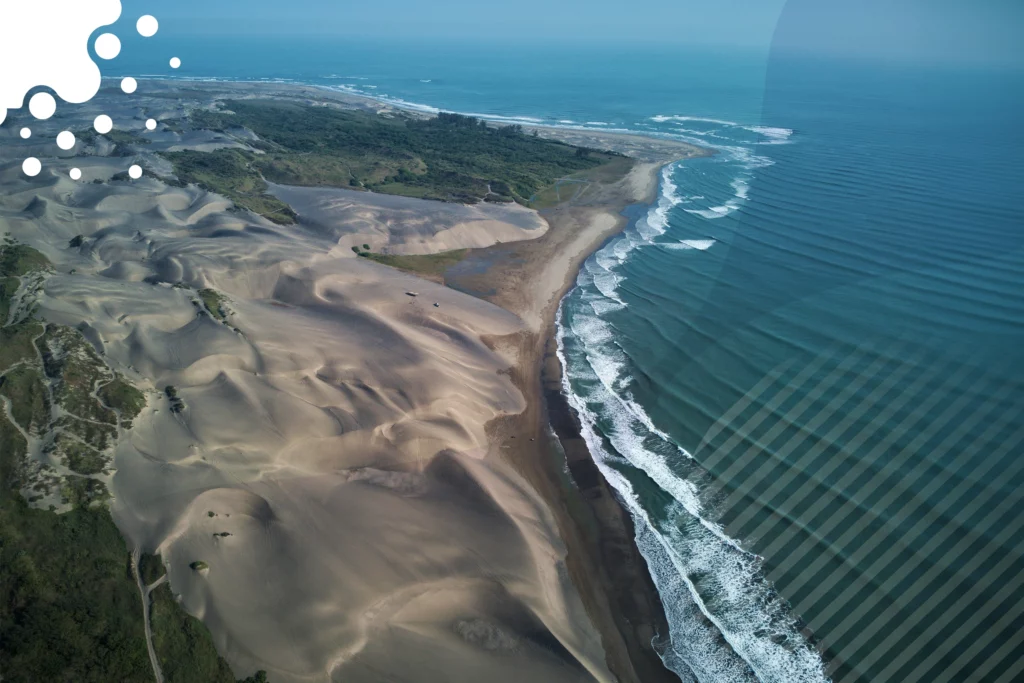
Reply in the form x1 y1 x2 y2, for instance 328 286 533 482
116 35 1024 683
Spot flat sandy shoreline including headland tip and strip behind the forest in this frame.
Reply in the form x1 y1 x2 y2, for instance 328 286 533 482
221 78 717 683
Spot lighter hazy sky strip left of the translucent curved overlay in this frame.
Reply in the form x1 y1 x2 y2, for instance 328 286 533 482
151 0 784 46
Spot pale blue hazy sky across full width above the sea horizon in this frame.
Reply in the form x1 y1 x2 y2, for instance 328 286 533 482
146 0 1024 65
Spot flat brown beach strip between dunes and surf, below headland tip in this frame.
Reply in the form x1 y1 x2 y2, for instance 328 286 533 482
456 159 681 683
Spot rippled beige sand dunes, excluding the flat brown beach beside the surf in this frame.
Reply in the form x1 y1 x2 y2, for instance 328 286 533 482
0 147 611 683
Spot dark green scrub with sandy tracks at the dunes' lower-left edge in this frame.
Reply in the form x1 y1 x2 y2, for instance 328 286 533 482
0 240 266 683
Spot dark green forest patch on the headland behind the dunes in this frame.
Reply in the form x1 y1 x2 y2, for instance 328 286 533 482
164 100 620 224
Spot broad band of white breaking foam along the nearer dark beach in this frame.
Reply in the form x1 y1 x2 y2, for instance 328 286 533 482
558 290 825 683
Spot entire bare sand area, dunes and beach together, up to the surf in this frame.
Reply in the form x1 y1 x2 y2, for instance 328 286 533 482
0 82 706 683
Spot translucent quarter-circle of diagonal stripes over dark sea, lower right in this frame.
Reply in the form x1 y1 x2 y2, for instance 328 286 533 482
694 343 1024 683
